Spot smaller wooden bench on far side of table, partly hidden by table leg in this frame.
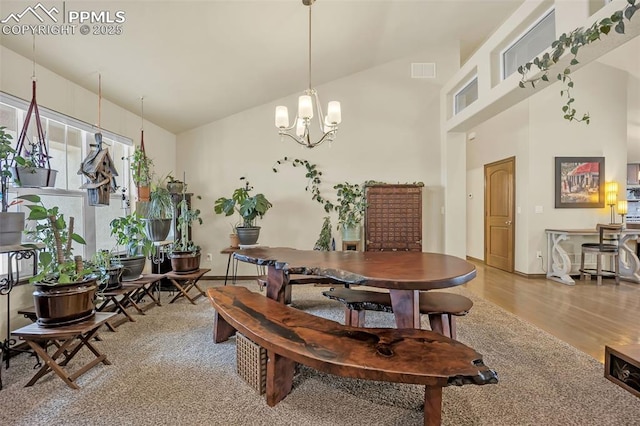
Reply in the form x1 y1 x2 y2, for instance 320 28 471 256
322 288 473 339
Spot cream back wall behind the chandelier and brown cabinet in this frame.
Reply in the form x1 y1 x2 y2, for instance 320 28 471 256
177 47 458 275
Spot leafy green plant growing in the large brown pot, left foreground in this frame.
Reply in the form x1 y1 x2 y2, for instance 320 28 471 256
18 195 95 285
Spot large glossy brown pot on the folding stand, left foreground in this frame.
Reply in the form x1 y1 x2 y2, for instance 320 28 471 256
33 278 98 327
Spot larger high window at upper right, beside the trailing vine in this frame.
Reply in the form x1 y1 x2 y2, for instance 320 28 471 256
501 9 556 80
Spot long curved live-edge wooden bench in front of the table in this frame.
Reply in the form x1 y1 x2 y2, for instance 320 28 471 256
207 286 498 425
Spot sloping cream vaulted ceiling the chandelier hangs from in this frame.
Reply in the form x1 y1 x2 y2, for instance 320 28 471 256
0 0 523 134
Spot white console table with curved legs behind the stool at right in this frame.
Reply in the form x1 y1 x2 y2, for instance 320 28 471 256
545 229 640 285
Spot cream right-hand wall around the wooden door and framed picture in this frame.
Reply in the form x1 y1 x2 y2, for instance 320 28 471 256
467 63 628 274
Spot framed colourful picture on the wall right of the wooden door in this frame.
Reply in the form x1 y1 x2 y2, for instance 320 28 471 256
555 157 604 209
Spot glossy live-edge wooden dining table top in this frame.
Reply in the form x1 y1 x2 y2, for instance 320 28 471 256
234 247 476 290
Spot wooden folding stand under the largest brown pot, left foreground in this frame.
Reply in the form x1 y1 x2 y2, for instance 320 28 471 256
11 312 116 389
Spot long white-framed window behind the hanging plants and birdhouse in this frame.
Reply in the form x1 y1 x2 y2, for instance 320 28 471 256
0 93 133 277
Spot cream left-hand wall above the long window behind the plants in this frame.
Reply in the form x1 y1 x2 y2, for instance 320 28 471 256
0 46 176 339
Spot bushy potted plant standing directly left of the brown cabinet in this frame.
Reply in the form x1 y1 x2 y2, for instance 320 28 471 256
333 182 367 241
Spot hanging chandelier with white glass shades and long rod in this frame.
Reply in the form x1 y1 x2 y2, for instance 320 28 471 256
276 0 342 148
